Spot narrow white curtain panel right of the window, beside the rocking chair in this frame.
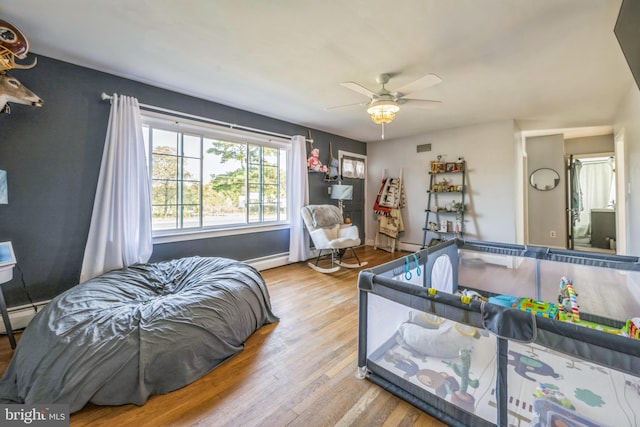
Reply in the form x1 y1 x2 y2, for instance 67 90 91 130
288 135 310 262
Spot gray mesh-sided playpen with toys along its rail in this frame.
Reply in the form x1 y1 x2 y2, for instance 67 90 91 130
358 239 640 427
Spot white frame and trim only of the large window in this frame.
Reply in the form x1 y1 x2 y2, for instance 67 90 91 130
141 110 292 243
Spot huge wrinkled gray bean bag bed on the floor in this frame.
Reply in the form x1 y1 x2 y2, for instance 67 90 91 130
0 257 278 412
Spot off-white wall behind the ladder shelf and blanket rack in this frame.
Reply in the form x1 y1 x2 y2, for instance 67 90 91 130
365 120 519 250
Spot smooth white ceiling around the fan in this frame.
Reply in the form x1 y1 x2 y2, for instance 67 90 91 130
0 0 632 141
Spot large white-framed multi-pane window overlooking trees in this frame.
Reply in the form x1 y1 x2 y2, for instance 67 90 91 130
143 112 290 236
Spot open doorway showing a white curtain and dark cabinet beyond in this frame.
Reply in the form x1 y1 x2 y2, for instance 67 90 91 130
567 153 617 254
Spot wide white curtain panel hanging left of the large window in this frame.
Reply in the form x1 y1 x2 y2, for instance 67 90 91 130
80 95 153 282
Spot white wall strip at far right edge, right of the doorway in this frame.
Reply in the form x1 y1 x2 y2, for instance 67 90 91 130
614 85 640 256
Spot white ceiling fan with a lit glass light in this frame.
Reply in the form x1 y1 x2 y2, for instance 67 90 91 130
332 74 442 138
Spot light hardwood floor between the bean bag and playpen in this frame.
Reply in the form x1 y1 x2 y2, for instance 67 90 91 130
0 247 445 427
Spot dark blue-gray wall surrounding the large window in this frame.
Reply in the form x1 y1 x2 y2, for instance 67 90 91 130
0 53 366 307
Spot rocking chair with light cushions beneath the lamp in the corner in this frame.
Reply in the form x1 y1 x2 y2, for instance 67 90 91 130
301 205 367 273
